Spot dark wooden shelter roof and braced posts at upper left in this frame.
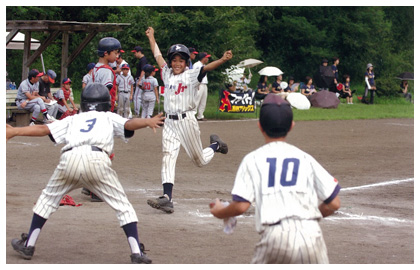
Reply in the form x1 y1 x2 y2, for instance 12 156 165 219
6 20 130 80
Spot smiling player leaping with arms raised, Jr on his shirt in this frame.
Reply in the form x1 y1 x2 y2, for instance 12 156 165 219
146 27 232 213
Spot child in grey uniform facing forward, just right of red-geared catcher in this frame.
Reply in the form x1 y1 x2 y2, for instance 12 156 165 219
117 64 135 118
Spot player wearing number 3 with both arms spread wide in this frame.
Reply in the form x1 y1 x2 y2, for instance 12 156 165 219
6 83 164 263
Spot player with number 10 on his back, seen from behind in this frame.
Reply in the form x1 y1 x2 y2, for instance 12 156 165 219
210 94 340 263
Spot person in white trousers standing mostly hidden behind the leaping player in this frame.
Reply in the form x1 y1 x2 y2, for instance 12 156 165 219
193 52 211 121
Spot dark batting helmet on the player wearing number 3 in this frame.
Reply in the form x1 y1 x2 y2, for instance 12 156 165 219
80 83 111 112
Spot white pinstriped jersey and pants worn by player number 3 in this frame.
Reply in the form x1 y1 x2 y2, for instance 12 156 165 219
33 111 137 226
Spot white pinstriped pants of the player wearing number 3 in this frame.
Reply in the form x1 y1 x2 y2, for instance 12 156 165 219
33 145 138 227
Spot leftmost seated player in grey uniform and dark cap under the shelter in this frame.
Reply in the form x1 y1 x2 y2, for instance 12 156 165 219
16 69 55 126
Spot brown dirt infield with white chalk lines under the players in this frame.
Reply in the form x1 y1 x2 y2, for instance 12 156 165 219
5 119 414 264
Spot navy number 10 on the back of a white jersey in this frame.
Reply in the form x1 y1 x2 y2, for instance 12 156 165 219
267 158 300 187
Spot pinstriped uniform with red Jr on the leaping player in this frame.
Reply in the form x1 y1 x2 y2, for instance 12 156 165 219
161 64 214 184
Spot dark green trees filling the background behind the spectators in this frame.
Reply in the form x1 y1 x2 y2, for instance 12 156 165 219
6 6 414 95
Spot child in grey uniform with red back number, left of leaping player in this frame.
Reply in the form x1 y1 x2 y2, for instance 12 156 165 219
140 64 160 118
